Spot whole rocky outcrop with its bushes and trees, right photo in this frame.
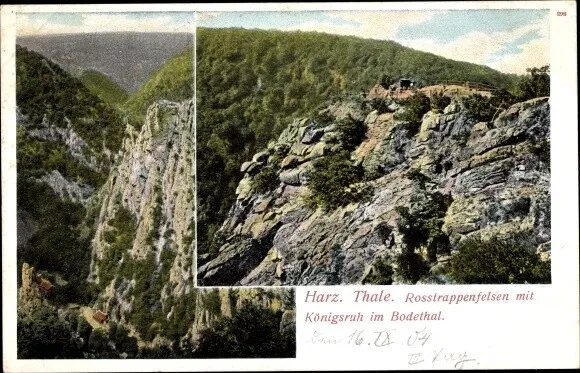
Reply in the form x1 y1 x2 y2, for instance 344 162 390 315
197 66 551 286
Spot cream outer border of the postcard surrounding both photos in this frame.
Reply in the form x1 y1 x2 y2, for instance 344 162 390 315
1 1 580 372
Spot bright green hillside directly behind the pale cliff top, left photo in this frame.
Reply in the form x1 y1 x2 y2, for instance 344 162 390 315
123 48 193 118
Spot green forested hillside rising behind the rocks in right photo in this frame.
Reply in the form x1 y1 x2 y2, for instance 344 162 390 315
196 28 516 253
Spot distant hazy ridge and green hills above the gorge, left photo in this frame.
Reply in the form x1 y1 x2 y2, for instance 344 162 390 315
18 33 193 126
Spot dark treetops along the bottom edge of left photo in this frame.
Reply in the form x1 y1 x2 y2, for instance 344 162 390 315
17 297 296 359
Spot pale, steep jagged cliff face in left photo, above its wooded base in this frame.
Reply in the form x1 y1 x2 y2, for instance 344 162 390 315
90 101 195 317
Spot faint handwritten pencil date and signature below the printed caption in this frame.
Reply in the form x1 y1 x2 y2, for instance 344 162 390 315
307 328 479 370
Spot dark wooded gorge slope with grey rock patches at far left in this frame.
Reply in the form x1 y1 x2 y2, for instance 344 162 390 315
16 45 125 288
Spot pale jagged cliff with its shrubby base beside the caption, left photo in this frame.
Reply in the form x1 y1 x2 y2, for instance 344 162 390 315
84 100 294 346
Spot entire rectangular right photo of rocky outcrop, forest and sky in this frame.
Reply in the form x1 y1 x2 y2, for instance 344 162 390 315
196 9 551 286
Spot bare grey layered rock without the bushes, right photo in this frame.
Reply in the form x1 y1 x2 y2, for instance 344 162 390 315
198 93 550 285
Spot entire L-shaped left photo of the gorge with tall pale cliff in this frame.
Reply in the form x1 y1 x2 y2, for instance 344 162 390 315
15 12 295 359
